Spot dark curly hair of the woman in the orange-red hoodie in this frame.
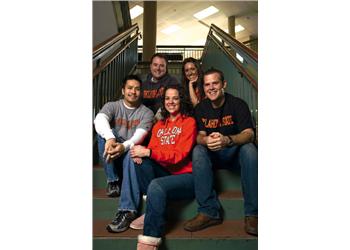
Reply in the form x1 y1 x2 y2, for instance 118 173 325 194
161 84 193 121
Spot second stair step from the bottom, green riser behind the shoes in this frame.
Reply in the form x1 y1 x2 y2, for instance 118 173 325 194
93 189 244 220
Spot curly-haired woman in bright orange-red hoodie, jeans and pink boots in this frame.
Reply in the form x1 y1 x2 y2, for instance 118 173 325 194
130 86 197 250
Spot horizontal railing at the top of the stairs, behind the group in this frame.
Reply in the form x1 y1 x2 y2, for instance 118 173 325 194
138 45 204 62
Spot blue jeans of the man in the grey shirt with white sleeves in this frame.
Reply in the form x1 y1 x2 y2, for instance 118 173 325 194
97 135 140 212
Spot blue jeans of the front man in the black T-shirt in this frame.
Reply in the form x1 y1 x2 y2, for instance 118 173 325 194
192 143 258 218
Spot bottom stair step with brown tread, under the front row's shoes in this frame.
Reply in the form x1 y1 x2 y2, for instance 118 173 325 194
93 220 258 250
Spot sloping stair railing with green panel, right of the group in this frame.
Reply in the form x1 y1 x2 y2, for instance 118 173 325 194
201 24 258 124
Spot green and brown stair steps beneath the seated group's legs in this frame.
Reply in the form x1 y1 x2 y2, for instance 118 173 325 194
93 165 258 250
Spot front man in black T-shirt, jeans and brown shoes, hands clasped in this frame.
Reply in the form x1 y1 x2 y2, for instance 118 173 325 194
184 69 258 235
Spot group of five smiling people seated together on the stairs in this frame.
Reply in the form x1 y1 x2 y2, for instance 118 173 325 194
94 53 258 250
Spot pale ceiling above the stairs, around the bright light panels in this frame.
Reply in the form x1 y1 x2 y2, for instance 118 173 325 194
129 1 258 45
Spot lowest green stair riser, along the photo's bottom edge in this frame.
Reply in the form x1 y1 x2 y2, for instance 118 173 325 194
93 238 258 250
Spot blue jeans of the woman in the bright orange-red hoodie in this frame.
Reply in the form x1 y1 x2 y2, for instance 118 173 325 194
136 158 194 238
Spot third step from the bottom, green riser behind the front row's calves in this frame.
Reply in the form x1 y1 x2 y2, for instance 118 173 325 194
93 165 241 192
